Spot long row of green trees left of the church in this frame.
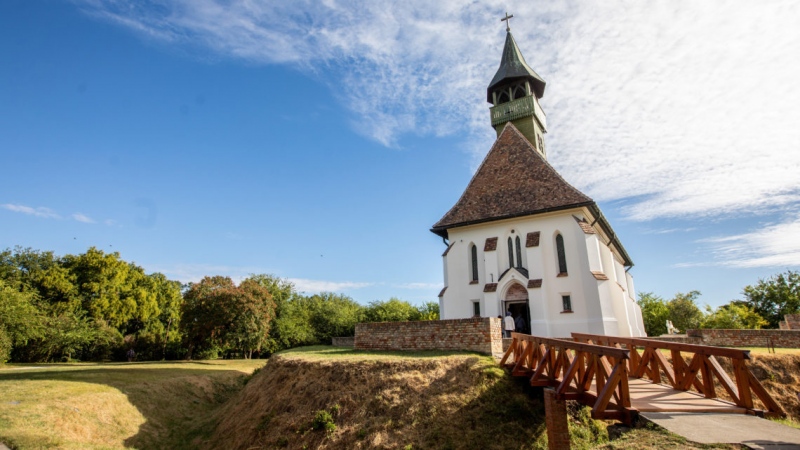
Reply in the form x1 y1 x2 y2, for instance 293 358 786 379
0 247 439 364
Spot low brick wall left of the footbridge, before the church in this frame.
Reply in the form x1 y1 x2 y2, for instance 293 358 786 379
355 317 503 355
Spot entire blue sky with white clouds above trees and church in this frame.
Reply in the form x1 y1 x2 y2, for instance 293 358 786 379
0 0 800 306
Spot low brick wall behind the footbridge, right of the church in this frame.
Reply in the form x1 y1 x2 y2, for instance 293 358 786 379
650 329 800 348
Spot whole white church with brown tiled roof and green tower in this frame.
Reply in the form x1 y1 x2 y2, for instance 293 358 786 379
431 21 646 337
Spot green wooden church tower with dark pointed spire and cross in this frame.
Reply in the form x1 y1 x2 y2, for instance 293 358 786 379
486 14 547 157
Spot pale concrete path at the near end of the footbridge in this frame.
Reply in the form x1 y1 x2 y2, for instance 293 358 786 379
639 412 800 450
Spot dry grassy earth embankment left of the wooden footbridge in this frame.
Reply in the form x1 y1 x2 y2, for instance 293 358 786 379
203 355 544 449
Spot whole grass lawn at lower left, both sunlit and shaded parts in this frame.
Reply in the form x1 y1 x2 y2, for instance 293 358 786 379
0 360 266 449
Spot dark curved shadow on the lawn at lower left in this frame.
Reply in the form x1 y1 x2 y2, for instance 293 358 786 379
0 361 258 449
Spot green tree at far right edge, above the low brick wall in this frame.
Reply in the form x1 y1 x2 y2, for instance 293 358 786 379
744 270 800 328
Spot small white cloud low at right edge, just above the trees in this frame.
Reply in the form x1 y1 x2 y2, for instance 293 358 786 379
701 215 800 268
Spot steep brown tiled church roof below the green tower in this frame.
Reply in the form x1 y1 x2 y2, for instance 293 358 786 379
431 122 594 237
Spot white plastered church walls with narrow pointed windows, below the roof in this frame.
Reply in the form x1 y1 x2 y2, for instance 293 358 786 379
442 210 633 337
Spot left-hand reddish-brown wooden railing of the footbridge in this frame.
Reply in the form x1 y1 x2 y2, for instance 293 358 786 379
500 333 636 424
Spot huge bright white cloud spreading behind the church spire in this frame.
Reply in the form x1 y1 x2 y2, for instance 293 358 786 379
75 0 800 220
